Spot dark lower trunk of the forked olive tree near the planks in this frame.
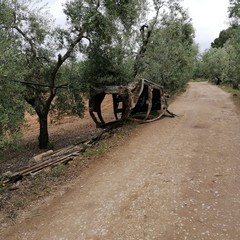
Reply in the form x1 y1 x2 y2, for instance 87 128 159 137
38 114 49 149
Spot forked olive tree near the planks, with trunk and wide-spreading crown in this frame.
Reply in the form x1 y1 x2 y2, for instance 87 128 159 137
0 0 145 148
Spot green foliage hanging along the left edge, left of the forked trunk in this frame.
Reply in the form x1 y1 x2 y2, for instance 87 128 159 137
0 25 25 149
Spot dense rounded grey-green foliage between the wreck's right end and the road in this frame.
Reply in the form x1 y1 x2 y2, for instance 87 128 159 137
141 15 197 91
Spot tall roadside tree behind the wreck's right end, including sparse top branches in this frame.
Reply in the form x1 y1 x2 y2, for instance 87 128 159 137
133 1 197 90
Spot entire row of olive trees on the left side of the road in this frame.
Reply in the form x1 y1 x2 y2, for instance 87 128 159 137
0 0 197 148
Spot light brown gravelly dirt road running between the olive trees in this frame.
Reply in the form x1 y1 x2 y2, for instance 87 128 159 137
0 83 240 240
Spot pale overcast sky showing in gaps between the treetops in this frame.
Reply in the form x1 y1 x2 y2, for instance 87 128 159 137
44 0 229 52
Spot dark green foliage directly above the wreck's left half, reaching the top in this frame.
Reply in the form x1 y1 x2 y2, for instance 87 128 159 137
66 0 145 88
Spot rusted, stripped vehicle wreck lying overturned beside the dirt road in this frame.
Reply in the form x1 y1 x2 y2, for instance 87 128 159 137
89 79 175 127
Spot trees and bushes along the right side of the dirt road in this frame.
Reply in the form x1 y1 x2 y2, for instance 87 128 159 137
194 0 240 95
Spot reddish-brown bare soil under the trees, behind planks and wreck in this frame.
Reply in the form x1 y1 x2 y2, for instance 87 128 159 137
0 96 114 175
